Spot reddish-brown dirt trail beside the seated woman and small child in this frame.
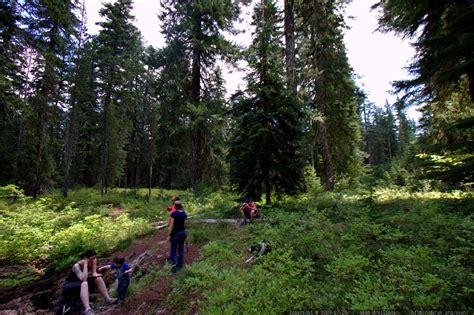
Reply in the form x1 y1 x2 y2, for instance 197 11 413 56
0 230 200 315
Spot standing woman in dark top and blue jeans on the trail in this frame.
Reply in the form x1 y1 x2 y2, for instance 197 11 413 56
168 200 187 273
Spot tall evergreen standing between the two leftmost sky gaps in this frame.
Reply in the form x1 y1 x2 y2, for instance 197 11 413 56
93 0 142 194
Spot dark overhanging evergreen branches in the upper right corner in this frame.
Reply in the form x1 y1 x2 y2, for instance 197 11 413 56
374 0 474 102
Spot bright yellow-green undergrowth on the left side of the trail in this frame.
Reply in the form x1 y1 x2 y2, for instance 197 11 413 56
0 185 243 284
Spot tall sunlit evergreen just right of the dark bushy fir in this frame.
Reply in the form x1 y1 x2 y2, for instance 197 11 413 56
299 1 362 190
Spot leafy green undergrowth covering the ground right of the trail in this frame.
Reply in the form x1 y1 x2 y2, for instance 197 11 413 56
162 189 474 314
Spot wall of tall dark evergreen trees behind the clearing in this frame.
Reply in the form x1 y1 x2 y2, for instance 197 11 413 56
0 0 474 201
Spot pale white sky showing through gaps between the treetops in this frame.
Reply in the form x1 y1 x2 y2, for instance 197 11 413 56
85 0 420 120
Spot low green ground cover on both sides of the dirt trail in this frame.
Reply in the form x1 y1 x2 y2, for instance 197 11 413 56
0 188 474 314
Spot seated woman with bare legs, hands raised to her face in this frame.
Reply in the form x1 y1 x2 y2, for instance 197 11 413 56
63 249 117 314
